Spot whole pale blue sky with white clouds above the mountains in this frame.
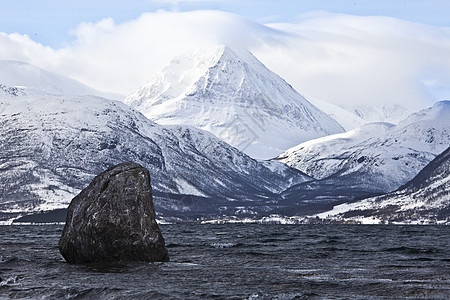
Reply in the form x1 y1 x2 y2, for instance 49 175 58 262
0 0 450 108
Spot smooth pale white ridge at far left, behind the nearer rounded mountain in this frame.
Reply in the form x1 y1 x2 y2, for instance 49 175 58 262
0 60 121 99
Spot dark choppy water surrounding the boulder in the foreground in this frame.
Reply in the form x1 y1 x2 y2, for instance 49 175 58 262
0 224 450 299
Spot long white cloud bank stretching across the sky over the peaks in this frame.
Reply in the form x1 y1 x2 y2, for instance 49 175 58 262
0 11 450 107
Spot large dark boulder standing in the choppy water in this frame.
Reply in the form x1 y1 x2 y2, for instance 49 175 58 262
59 162 169 264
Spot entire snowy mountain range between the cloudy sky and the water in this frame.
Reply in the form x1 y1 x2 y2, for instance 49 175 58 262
0 46 450 222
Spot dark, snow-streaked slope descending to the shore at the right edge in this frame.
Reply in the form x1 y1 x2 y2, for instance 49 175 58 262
320 148 450 223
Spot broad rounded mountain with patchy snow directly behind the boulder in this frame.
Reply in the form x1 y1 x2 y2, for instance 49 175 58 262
0 87 310 220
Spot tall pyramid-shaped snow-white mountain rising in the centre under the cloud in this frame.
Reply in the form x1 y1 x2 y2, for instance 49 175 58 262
125 46 344 159
